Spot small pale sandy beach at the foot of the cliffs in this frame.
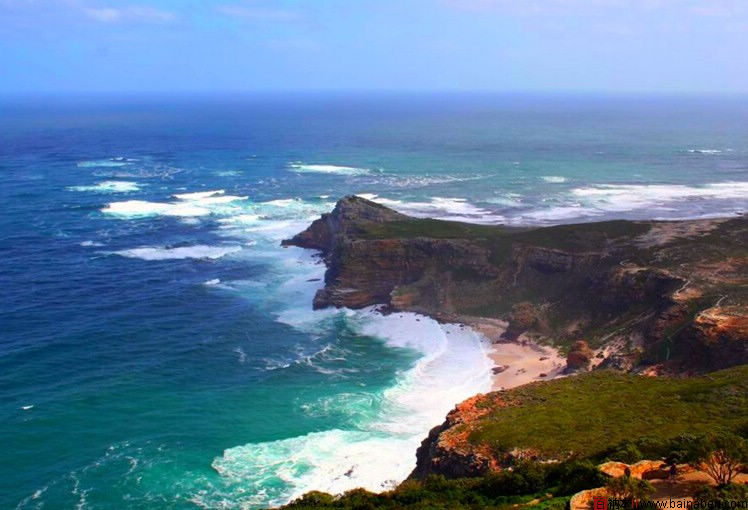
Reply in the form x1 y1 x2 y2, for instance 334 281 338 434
459 316 566 391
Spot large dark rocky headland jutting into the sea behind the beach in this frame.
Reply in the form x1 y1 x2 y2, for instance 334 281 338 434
284 196 748 372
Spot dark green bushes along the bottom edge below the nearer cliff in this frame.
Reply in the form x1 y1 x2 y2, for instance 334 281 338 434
283 461 606 510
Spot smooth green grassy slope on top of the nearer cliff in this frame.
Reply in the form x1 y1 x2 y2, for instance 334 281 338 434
470 365 748 457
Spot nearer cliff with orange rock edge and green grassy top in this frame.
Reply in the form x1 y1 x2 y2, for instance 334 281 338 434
411 366 748 479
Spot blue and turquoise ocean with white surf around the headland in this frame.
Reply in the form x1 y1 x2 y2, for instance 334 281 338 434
0 93 748 509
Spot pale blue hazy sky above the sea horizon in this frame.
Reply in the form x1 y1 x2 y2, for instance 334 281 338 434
0 0 748 94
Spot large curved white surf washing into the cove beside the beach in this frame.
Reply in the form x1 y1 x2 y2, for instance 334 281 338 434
207 309 492 506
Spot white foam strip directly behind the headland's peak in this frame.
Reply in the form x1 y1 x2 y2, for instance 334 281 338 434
357 193 505 224
